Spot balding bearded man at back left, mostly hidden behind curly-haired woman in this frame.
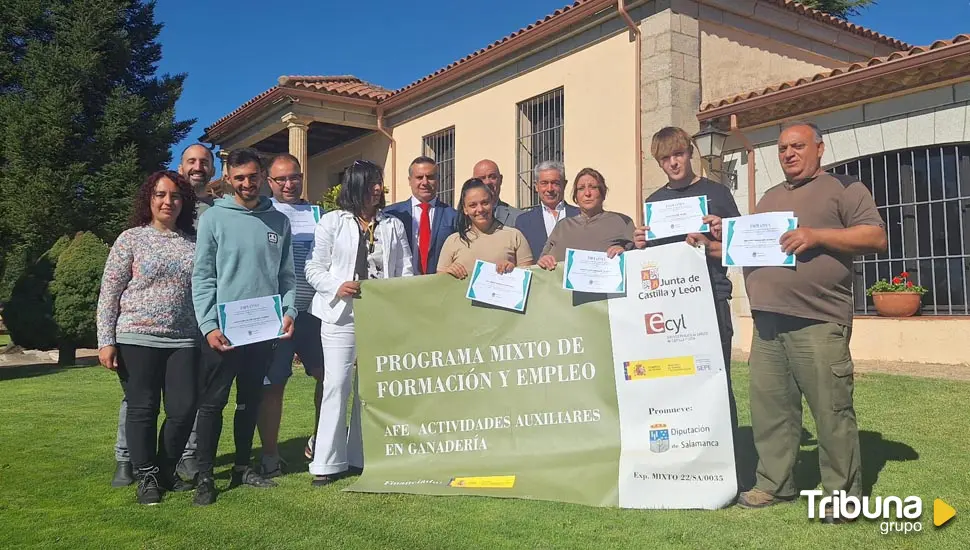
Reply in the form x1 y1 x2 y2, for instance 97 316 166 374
111 143 215 487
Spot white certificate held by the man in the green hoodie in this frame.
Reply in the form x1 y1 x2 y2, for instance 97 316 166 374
218 294 283 346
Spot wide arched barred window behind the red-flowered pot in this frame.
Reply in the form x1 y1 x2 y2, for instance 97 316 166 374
829 143 970 315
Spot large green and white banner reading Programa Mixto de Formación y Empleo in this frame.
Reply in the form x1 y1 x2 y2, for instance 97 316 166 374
350 245 735 508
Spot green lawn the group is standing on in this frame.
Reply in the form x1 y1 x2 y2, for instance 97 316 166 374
0 364 970 550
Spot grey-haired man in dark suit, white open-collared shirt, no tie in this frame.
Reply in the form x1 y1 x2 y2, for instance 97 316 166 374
515 160 579 257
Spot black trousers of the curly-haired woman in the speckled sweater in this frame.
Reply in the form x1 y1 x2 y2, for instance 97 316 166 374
118 344 199 470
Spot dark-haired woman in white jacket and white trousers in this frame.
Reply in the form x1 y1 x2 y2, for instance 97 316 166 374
305 160 412 486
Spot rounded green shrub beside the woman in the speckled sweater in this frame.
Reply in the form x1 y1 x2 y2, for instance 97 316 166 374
50 232 109 362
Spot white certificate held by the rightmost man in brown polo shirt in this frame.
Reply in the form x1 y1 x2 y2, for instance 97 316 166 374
721 212 798 267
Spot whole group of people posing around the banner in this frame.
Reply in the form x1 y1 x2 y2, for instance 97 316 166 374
98 122 886 521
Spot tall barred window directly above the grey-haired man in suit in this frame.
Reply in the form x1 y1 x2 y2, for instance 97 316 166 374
516 88 564 208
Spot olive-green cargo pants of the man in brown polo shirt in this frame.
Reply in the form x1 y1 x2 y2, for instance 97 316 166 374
749 311 862 498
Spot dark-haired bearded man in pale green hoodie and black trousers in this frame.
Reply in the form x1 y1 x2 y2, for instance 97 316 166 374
192 149 297 505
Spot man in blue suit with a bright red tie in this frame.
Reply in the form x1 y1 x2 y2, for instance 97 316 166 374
384 157 458 275
